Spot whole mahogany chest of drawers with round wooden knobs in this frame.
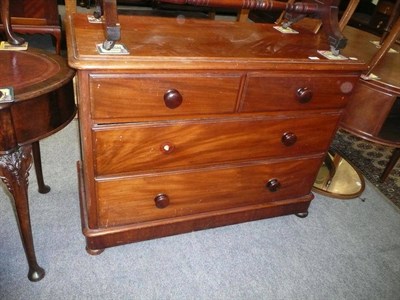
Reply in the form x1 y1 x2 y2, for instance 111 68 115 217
67 14 364 254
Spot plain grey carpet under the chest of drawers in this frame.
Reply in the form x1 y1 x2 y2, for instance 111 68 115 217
0 121 400 300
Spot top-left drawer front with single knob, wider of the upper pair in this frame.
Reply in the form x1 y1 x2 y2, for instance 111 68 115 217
90 74 241 122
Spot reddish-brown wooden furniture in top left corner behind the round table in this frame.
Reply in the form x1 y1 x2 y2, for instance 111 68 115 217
0 0 62 54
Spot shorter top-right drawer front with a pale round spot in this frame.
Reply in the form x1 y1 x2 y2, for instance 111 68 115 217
240 74 358 112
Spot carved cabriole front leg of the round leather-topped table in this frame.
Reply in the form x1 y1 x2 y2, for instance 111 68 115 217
0 145 45 281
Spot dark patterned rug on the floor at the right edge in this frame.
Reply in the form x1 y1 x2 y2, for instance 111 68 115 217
332 130 400 208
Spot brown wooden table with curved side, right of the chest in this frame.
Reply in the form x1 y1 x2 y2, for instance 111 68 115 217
340 19 400 181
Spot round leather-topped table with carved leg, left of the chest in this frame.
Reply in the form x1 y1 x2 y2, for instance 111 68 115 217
0 50 76 281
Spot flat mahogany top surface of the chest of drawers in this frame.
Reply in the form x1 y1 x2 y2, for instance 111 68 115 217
66 14 365 71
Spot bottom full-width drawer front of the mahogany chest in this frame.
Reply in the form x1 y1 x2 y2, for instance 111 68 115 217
96 157 322 227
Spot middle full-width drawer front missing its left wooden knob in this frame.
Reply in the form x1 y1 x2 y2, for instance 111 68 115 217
93 114 339 175
